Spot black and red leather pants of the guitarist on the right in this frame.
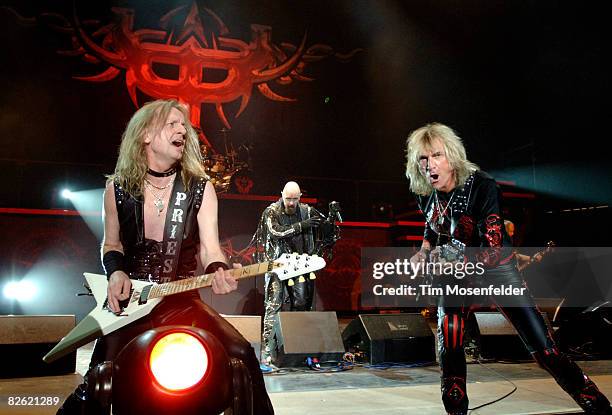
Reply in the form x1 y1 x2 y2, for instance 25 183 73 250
438 261 612 414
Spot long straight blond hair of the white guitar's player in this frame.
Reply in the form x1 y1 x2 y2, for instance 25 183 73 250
108 99 207 196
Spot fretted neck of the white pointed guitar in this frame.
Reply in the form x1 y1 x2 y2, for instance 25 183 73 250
147 261 273 299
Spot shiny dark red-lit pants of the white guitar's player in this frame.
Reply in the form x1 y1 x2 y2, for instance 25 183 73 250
58 291 274 415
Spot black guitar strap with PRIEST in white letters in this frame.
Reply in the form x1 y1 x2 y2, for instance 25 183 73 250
160 176 187 282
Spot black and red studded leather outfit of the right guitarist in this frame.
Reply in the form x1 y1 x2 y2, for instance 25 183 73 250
417 171 612 414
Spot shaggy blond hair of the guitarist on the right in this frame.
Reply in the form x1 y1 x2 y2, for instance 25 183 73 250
406 123 479 196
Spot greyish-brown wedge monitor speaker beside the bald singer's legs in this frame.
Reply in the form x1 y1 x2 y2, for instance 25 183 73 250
274 311 344 367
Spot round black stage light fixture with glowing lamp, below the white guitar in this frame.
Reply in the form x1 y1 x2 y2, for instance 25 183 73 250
107 326 234 415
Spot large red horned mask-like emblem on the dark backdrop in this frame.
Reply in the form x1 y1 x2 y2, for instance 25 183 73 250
23 2 360 147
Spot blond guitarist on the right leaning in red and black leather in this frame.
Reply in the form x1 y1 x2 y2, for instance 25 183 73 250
406 123 612 415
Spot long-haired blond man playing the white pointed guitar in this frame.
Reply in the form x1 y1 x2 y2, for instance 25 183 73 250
58 100 274 414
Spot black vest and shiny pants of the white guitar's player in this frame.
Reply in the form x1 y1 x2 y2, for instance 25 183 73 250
58 179 274 414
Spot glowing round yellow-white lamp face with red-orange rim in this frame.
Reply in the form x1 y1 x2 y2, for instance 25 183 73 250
149 333 208 392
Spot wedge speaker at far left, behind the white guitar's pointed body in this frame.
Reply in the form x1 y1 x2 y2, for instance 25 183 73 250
0 315 76 378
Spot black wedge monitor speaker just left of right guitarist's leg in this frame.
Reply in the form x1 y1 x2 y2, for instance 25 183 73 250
342 313 436 364
